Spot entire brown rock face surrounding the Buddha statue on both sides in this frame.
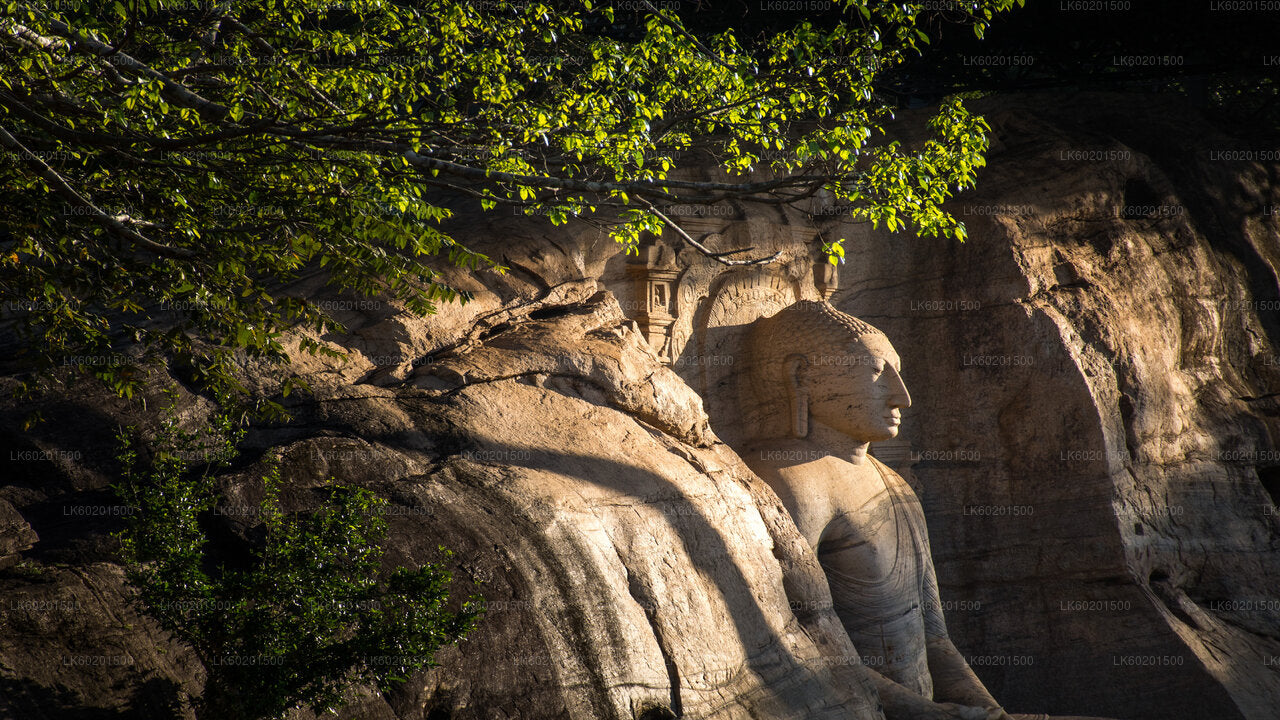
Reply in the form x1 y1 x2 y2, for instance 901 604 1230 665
0 90 1280 720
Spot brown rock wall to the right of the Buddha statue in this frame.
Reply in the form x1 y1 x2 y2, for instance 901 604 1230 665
833 90 1280 720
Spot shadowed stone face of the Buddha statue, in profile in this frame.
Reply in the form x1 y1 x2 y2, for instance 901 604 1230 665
801 333 911 442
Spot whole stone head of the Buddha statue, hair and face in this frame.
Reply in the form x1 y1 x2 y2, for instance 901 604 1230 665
748 300 911 442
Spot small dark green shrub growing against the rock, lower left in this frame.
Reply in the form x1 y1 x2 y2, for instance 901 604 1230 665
116 397 480 720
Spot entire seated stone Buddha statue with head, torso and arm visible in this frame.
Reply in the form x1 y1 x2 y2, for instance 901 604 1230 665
742 301 1116 720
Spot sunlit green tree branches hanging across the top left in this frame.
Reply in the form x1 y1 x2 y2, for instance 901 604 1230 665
0 0 1021 393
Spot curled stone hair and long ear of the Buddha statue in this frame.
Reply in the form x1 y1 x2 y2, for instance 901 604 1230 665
742 300 884 437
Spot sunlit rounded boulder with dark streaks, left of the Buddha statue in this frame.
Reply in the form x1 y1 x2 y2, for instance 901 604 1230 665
4 292 879 720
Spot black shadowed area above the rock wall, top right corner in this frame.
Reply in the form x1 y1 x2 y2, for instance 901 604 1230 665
878 0 1280 136
